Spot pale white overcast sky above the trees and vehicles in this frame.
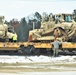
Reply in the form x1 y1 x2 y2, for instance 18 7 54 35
0 0 76 21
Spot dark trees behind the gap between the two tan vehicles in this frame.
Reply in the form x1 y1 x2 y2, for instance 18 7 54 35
5 12 41 42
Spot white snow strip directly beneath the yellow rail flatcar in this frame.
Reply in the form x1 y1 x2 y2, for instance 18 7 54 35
0 55 76 63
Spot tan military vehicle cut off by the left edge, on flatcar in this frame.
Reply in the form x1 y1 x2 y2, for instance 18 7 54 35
0 16 17 42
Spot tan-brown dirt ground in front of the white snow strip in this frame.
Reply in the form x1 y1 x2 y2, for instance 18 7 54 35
0 62 76 73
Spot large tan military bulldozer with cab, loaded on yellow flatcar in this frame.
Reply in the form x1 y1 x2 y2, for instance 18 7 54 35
29 13 76 42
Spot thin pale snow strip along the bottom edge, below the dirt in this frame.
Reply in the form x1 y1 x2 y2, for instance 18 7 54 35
0 72 76 75
